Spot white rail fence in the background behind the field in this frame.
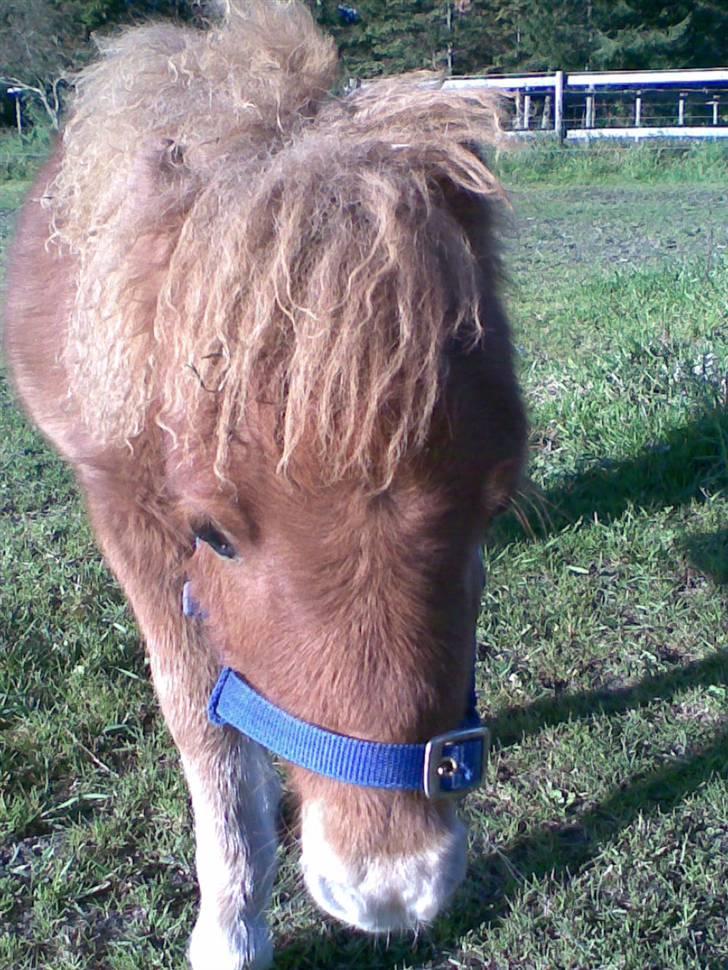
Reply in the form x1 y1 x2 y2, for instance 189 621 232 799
445 68 728 141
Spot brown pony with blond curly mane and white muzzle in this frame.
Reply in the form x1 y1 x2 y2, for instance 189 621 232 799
1 0 525 970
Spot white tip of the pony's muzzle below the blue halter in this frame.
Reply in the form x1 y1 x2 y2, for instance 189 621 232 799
301 801 467 933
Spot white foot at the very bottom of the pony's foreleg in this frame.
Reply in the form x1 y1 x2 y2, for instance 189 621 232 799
189 915 273 970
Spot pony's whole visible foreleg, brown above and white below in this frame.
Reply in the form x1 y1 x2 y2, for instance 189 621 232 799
88 489 278 970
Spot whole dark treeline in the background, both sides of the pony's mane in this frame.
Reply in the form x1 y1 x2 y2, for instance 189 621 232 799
0 0 728 124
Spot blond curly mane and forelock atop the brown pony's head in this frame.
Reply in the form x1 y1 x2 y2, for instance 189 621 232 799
46 0 500 482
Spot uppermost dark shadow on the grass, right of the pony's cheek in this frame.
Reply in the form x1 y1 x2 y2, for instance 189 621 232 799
489 407 728 548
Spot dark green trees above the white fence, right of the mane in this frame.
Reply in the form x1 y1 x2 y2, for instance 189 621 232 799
307 0 728 77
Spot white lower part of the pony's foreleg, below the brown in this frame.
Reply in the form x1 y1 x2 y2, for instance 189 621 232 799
149 643 278 970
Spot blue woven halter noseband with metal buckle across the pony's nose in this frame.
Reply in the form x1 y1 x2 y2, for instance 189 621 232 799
208 667 489 798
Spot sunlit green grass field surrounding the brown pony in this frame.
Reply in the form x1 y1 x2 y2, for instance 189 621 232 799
0 146 728 970
